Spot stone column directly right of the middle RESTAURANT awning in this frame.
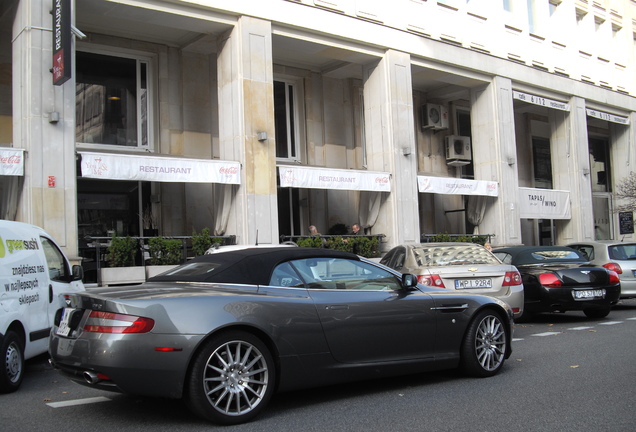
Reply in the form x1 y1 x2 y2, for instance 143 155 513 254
364 50 420 249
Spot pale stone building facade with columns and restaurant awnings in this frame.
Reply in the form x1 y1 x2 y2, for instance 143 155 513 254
0 0 636 266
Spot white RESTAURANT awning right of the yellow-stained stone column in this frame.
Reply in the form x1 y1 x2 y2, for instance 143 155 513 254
278 165 391 192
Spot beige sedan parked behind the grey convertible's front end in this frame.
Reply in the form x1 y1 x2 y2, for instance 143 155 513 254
380 242 523 318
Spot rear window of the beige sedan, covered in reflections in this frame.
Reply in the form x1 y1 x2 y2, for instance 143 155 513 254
413 245 500 267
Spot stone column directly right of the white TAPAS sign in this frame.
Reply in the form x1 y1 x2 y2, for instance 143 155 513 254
548 97 594 244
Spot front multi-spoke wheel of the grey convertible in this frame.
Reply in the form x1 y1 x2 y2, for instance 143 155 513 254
460 310 508 377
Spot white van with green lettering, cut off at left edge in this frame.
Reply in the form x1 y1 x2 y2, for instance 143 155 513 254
0 220 84 393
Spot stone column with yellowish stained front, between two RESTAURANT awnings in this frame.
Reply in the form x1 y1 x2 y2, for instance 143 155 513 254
217 17 278 244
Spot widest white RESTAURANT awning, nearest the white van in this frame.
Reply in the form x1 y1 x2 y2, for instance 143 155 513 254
79 152 241 184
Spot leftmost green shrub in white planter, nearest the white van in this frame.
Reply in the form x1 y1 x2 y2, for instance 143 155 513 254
100 236 146 286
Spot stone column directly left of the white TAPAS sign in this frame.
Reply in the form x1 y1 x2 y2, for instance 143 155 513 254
470 77 521 246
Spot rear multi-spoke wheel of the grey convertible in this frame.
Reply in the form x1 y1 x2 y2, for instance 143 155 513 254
185 331 276 425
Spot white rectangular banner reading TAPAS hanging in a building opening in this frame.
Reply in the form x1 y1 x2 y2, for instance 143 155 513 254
519 187 572 219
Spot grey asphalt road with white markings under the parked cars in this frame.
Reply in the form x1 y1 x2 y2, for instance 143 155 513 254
0 300 636 432
